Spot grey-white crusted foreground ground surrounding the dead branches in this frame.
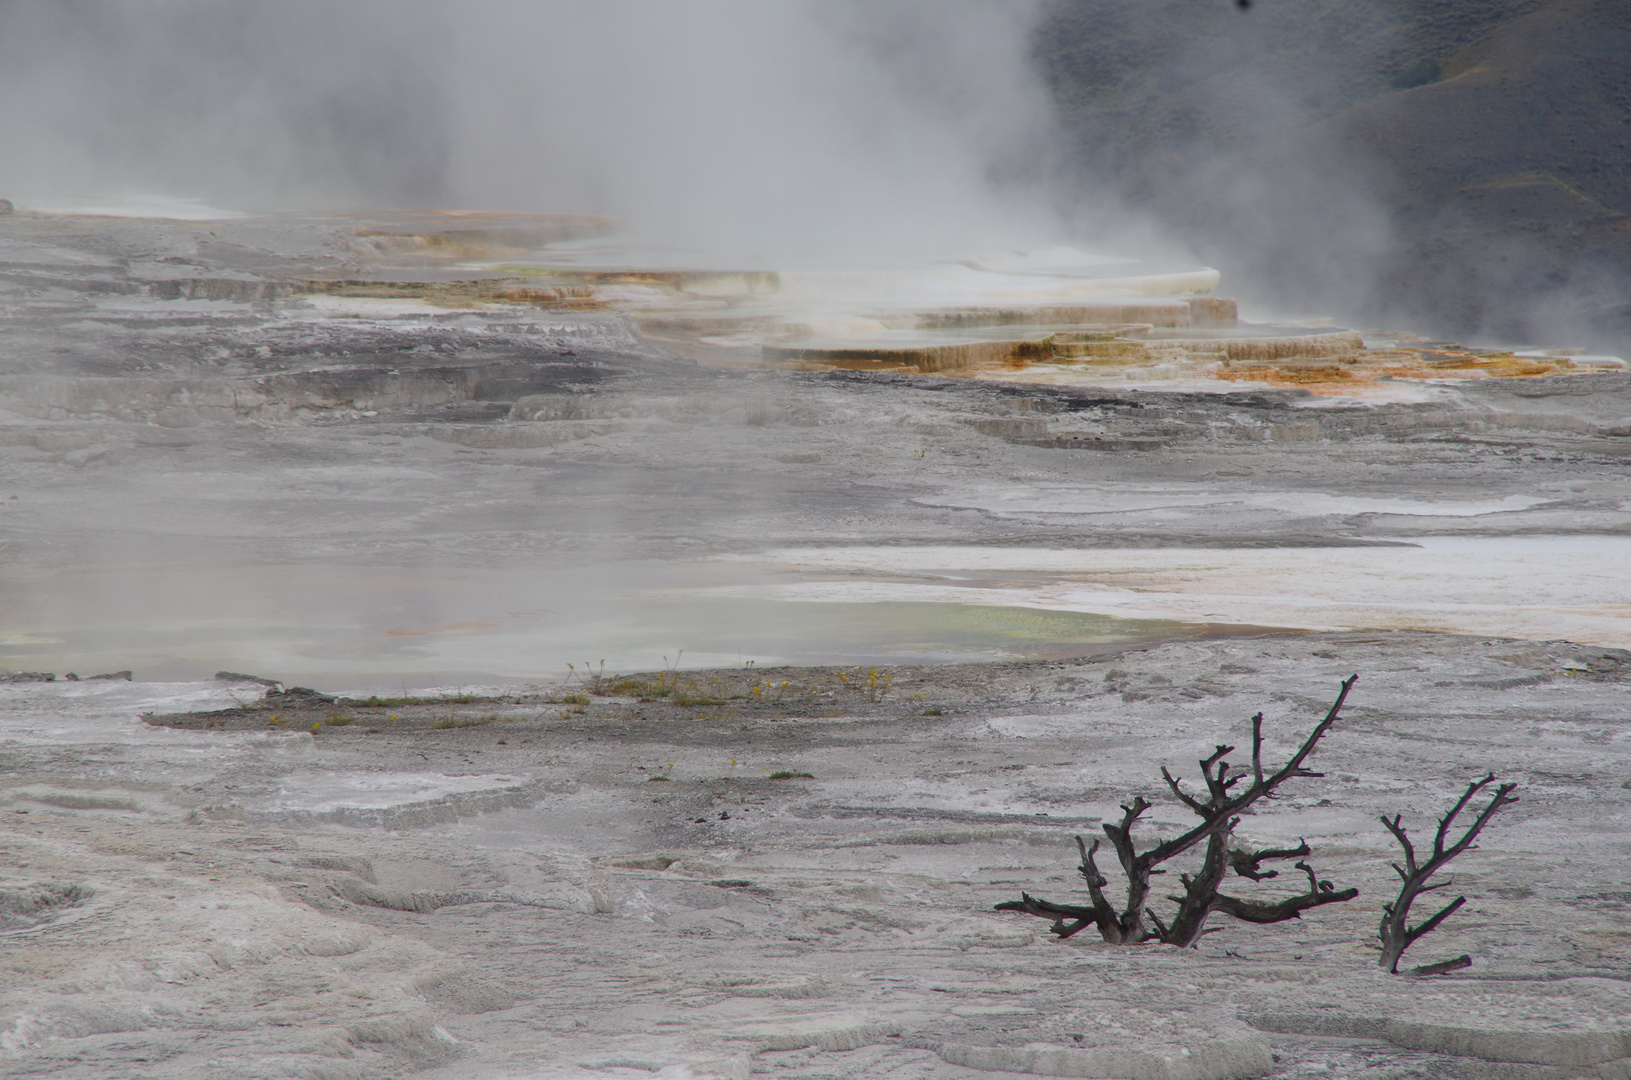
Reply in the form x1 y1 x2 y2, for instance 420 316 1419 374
0 635 1631 1080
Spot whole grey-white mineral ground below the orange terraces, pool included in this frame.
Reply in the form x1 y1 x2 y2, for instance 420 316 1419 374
0 209 1631 1080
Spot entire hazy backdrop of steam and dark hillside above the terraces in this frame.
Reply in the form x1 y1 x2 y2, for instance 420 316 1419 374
0 0 1631 351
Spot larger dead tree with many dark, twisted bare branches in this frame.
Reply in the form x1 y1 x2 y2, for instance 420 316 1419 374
997 675 1359 945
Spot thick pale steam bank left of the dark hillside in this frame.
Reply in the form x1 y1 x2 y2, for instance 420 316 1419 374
0 0 1057 259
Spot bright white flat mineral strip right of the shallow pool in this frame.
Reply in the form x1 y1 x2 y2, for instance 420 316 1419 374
727 535 1631 648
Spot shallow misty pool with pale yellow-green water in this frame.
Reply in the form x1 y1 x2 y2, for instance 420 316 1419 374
0 564 1220 688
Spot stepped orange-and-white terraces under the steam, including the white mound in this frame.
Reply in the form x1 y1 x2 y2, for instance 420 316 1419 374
303 212 1623 393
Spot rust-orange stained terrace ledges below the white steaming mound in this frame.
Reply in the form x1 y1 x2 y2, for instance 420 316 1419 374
277 210 1604 393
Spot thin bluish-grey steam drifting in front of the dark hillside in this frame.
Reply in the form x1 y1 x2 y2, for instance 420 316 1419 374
1037 0 1396 326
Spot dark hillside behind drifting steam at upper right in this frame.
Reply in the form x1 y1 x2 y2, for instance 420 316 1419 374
1037 0 1631 349
